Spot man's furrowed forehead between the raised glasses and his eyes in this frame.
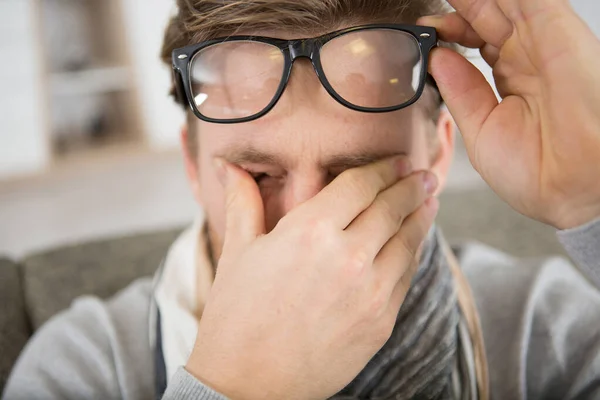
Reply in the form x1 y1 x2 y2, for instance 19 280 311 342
199 104 419 169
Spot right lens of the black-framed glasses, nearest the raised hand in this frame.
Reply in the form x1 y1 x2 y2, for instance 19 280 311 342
321 29 423 108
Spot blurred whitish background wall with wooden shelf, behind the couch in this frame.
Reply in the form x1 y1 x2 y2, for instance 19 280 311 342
0 0 600 256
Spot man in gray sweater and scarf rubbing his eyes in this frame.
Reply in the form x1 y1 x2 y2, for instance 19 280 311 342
5 0 600 399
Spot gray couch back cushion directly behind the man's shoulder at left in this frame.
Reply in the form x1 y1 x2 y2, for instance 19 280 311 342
22 229 181 330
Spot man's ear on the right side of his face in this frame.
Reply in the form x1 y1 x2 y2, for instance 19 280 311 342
431 109 455 196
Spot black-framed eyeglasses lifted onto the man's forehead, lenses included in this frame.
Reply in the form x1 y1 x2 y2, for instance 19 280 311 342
173 24 437 123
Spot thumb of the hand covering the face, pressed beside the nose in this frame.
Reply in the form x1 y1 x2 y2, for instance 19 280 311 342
215 158 265 254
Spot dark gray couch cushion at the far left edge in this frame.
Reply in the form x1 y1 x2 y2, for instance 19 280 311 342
0 259 31 391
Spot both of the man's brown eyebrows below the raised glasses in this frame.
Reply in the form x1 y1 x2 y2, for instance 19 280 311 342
218 147 407 169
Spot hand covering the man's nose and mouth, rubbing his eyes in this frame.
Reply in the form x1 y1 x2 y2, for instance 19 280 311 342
186 159 437 399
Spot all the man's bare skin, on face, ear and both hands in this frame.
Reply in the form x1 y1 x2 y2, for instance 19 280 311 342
186 0 600 399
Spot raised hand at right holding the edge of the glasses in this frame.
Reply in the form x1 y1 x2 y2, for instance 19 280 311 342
419 0 600 229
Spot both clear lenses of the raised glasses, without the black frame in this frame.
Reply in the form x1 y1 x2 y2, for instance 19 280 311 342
190 29 423 119
